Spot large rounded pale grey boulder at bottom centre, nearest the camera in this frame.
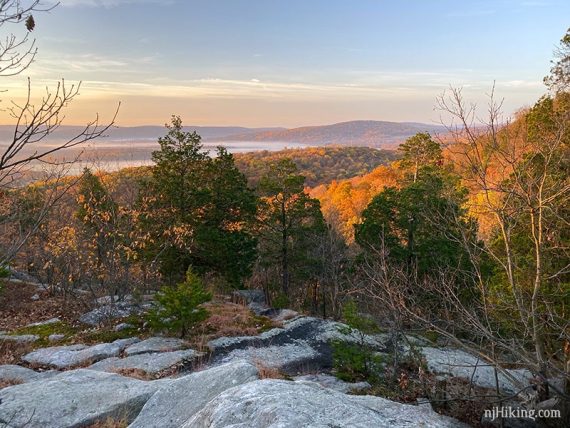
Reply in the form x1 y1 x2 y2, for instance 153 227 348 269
182 379 466 428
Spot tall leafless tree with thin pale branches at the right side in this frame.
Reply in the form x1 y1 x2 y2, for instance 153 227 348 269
432 88 570 398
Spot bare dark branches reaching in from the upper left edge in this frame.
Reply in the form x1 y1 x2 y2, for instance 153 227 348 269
0 0 118 265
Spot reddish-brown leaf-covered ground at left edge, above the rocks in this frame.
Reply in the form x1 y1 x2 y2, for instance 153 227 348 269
0 281 87 331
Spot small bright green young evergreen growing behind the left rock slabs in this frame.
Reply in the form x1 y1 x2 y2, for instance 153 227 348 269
147 268 212 337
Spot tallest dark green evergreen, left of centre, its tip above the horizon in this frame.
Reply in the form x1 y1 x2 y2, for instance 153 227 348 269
144 117 256 286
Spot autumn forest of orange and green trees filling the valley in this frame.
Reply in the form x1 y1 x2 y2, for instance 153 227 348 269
0 21 570 428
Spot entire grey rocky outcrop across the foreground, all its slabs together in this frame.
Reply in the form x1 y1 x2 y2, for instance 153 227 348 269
0 313 530 428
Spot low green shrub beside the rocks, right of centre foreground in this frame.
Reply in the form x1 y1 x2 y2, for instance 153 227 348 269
332 301 384 383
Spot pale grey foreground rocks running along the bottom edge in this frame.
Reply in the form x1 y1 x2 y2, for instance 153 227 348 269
0 360 464 428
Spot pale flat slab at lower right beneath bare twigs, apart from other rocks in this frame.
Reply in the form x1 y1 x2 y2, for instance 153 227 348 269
421 347 532 393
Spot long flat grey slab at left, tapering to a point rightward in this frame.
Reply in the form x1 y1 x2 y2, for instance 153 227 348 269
22 338 139 370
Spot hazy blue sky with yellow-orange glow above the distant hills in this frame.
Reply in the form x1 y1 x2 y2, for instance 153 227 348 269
2 0 570 126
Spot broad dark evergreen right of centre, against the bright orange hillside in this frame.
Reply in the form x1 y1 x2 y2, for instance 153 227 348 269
355 168 476 276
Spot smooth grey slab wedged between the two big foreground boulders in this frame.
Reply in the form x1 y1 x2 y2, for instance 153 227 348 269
129 361 258 428
